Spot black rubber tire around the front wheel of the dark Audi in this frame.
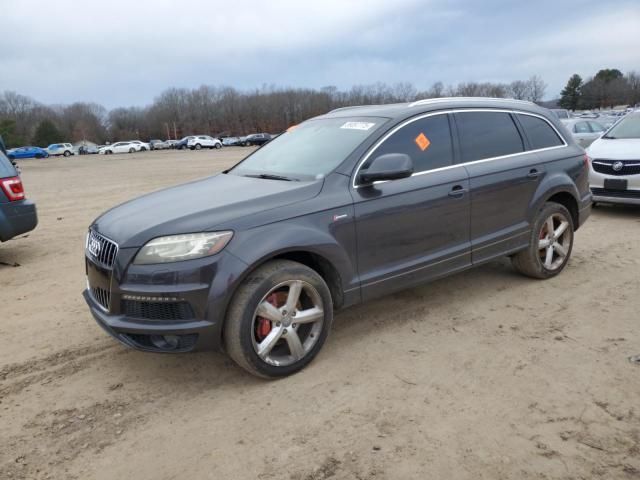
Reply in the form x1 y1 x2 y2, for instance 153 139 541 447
223 260 333 378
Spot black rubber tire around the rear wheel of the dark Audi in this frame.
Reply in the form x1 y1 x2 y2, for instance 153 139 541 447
511 202 575 280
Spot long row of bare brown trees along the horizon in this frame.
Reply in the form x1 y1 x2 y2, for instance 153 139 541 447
0 68 637 147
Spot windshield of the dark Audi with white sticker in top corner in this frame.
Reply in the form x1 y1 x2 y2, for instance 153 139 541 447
229 117 387 180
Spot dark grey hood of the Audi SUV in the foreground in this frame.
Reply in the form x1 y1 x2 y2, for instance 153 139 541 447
93 174 322 248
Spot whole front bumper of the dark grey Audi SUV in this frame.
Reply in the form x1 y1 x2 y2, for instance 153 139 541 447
83 248 247 353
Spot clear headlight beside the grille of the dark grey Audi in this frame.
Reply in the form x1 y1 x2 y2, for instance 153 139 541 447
133 232 233 265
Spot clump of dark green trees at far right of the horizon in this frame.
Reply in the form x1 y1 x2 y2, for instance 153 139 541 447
558 68 640 110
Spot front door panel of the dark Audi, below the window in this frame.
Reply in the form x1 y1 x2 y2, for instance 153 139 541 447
353 166 471 300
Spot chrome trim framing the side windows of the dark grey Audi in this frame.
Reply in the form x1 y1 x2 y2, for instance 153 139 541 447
351 108 569 188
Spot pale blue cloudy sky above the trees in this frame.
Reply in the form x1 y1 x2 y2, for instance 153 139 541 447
0 0 640 108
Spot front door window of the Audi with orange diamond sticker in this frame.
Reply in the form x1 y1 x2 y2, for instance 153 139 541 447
370 114 453 173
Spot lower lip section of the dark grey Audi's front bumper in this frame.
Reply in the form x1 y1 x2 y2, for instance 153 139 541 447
82 290 219 353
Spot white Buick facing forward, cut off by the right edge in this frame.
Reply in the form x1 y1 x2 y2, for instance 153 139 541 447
587 112 640 205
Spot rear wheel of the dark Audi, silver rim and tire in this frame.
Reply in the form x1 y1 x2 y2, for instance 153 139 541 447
511 202 574 279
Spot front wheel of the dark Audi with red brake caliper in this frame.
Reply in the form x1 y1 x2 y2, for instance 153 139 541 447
224 260 333 378
